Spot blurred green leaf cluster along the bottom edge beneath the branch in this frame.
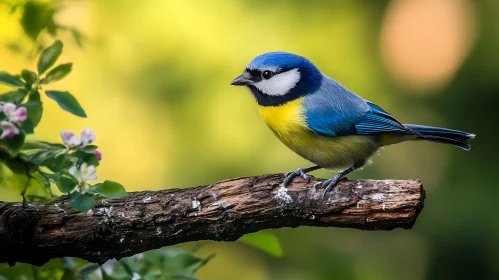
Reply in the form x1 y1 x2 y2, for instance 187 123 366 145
0 248 215 280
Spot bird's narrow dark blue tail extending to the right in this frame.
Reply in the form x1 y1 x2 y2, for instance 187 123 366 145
404 124 475 150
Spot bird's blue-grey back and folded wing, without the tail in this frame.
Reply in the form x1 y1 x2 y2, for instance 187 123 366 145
303 77 414 136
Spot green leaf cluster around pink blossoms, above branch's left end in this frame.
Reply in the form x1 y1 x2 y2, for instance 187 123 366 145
0 40 126 211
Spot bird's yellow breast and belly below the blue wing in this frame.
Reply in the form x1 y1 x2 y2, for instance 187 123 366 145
260 100 379 170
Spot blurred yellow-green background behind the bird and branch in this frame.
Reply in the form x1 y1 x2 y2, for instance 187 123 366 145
0 0 499 280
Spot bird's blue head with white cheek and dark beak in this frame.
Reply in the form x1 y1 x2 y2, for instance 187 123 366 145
231 52 322 106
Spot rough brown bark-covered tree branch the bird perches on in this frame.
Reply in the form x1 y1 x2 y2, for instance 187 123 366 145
0 174 425 265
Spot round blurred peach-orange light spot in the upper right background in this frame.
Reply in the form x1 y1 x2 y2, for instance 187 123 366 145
381 0 478 93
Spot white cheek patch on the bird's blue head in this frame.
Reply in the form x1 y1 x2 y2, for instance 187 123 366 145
254 68 300 96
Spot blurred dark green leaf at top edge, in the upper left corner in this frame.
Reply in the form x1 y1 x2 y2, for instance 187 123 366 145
20 1 55 41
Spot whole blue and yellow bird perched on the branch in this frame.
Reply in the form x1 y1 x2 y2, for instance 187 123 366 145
231 52 475 195
